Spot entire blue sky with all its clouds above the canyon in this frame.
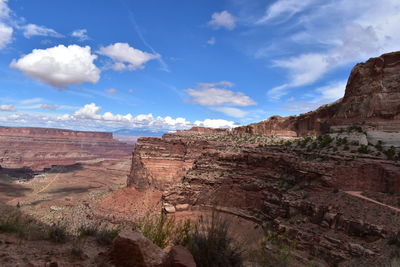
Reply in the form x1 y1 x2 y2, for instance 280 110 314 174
0 0 400 131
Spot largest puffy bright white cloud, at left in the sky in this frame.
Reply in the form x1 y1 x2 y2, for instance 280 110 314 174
10 45 100 88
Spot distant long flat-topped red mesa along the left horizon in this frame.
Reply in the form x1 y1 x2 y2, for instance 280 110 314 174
0 127 133 170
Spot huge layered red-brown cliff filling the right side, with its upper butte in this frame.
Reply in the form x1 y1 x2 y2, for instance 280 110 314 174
127 52 400 265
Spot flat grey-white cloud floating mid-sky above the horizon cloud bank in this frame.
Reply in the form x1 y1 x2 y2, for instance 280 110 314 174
185 81 257 107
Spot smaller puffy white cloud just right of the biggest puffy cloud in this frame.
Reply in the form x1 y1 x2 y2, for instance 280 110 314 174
97 43 161 70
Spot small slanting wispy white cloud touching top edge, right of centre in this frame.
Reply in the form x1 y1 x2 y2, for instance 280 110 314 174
257 0 318 23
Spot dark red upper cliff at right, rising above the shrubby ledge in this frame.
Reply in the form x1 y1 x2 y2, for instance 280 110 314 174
234 52 400 140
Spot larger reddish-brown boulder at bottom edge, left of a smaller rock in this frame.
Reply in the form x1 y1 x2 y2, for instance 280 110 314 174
110 230 168 267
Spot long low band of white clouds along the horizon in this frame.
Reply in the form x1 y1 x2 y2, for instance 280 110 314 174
0 103 238 131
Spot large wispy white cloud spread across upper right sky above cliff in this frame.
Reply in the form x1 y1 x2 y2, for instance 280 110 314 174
266 0 400 98
